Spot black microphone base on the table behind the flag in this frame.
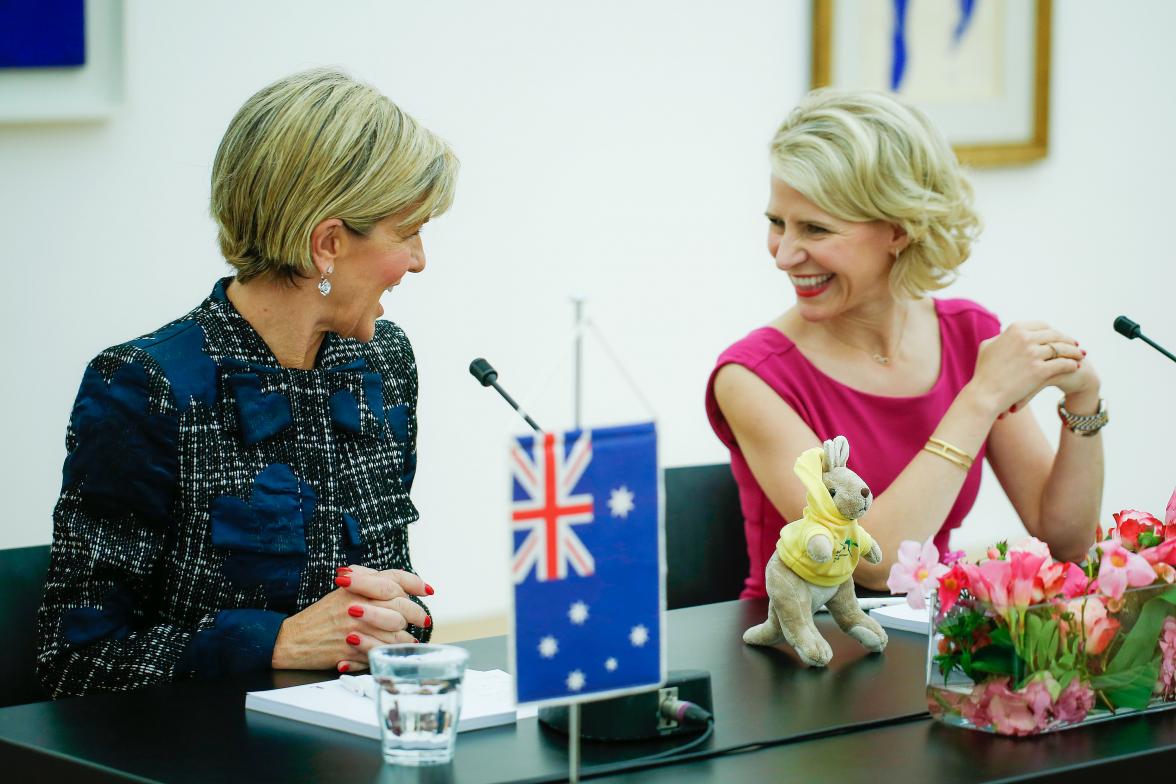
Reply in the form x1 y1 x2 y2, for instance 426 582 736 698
539 670 711 741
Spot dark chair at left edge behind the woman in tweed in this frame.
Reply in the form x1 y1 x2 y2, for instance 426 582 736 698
0 544 49 708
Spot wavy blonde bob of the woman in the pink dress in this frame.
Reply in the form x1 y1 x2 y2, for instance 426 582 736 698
771 88 981 299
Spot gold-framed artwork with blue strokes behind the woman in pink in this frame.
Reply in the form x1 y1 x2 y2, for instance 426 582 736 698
813 0 1053 166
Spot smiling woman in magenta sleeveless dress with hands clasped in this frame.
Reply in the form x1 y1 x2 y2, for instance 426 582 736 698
707 89 1107 598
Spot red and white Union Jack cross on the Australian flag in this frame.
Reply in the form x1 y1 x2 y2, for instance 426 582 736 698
510 433 596 583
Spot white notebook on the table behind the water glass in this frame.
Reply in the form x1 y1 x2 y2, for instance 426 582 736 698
245 670 516 738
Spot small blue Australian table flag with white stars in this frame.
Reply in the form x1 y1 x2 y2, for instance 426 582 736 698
510 423 664 703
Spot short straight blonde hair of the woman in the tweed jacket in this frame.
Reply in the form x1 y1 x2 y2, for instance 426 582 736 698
212 68 457 283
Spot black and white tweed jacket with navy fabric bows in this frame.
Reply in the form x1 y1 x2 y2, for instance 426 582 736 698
38 279 429 696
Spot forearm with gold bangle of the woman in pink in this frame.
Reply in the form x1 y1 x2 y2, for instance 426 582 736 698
854 384 996 590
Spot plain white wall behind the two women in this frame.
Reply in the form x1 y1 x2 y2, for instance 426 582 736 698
0 0 1176 621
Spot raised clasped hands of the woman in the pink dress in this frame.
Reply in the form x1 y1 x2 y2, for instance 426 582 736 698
970 321 1098 417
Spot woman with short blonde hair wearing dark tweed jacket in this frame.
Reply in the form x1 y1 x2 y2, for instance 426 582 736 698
38 69 457 696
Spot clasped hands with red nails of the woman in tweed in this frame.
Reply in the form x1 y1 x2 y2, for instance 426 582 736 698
273 565 433 672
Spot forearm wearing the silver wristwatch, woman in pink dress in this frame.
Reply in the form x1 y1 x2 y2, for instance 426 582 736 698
1034 390 1103 561
